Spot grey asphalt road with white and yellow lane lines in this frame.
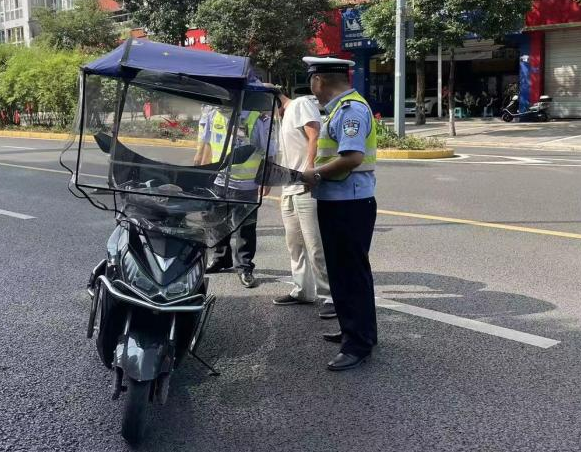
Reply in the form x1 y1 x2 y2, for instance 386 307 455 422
0 138 581 452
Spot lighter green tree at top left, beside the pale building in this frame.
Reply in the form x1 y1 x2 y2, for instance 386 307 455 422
34 0 119 53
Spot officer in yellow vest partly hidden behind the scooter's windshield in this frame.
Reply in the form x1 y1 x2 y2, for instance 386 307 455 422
206 110 270 288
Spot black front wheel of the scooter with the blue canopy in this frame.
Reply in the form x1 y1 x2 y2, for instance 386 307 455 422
121 378 151 446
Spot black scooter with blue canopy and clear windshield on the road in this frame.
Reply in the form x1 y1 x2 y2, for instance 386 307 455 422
61 39 286 444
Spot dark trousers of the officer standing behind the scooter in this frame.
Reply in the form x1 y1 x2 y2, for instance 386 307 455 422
213 189 258 271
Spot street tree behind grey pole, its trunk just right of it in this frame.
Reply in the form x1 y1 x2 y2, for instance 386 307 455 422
361 0 443 125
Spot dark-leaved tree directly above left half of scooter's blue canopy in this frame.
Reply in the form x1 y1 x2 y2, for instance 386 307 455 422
124 0 200 44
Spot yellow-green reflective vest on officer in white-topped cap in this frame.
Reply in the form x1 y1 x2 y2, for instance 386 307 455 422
315 91 377 180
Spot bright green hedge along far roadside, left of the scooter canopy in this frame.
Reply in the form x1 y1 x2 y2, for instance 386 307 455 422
0 45 91 128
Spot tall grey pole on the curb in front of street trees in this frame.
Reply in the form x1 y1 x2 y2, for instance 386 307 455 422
394 0 406 137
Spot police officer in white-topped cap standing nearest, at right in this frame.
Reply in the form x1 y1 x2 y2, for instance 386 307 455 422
303 57 377 371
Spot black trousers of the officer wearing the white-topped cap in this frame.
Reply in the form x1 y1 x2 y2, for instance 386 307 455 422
317 198 377 356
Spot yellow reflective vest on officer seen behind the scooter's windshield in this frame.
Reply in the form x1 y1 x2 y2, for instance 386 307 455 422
210 111 264 180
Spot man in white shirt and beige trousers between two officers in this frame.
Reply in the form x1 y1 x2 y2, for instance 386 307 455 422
273 87 337 319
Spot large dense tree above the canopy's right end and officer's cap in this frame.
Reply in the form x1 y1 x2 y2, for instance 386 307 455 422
195 0 331 90
